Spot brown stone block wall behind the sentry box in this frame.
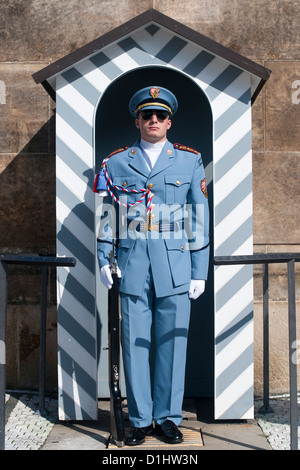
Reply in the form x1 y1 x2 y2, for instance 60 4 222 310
0 0 300 394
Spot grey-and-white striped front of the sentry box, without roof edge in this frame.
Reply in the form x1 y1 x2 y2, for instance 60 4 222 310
32 12 270 420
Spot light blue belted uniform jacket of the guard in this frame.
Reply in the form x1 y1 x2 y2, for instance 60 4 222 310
95 141 209 297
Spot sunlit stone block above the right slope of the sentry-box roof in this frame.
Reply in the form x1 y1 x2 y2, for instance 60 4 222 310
154 0 300 60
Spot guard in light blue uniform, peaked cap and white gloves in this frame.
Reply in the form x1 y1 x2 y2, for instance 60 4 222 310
94 86 209 445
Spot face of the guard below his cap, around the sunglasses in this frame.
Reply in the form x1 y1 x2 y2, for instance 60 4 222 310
135 110 171 144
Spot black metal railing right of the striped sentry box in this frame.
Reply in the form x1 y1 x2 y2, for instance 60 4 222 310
214 253 300 450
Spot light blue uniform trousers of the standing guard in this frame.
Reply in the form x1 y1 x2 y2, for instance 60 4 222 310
120 262 190 427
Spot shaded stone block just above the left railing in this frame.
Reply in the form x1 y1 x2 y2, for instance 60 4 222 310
0 154 56 252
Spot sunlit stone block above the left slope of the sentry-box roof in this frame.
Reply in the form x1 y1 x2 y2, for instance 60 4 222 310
0 0 153 61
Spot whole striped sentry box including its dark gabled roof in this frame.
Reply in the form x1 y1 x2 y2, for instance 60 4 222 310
34 10 270 420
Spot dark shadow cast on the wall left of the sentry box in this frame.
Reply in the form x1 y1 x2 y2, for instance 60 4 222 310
0 115 57 392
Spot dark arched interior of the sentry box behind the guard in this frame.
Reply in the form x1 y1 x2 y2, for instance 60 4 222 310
94 66 214 397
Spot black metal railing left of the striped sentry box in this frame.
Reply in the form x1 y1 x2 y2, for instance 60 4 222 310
0 254 76 450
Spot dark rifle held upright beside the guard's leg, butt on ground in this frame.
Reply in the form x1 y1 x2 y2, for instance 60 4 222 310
108 242 125 447
